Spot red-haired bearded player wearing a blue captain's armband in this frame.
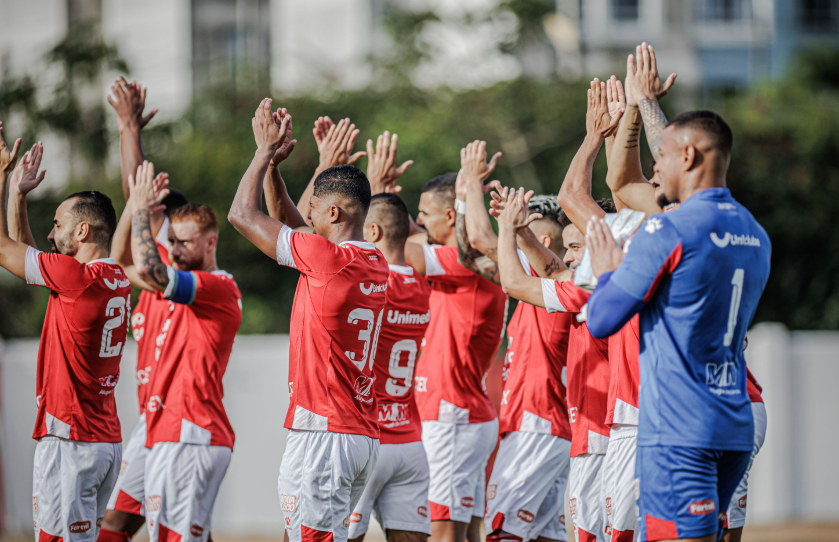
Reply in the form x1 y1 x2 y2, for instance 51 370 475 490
130 162 242 542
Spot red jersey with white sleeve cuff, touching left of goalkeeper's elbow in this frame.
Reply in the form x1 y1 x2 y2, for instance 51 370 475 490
542 279 609 457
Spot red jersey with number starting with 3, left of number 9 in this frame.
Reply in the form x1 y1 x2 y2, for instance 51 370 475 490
277 226 389 438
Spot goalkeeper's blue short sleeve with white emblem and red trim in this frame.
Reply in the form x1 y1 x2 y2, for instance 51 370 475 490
610 215 682 302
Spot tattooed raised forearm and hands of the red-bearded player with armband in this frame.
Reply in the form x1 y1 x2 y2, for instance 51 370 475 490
128 161 169 292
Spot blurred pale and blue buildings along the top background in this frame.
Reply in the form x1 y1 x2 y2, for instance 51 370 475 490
0 0 839 117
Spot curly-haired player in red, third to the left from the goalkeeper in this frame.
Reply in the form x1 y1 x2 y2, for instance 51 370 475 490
456 141 573 540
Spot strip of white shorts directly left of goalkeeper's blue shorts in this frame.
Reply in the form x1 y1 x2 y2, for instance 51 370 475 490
602 425 638 542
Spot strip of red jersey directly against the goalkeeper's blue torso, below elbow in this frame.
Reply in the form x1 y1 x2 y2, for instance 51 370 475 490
606 314 641 425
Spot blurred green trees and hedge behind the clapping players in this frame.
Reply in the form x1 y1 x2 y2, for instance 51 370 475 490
0 43 839 336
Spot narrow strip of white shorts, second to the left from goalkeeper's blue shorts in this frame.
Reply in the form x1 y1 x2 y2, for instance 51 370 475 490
568 454 606 542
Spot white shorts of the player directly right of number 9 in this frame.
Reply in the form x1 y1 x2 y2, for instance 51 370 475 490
422 419 498 523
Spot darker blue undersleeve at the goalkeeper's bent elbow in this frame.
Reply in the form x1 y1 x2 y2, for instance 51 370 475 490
586 272 646 339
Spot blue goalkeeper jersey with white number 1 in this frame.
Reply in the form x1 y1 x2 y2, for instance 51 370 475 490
588 188 771 451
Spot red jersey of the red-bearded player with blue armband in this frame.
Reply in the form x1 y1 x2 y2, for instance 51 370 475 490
146 267 242 448
